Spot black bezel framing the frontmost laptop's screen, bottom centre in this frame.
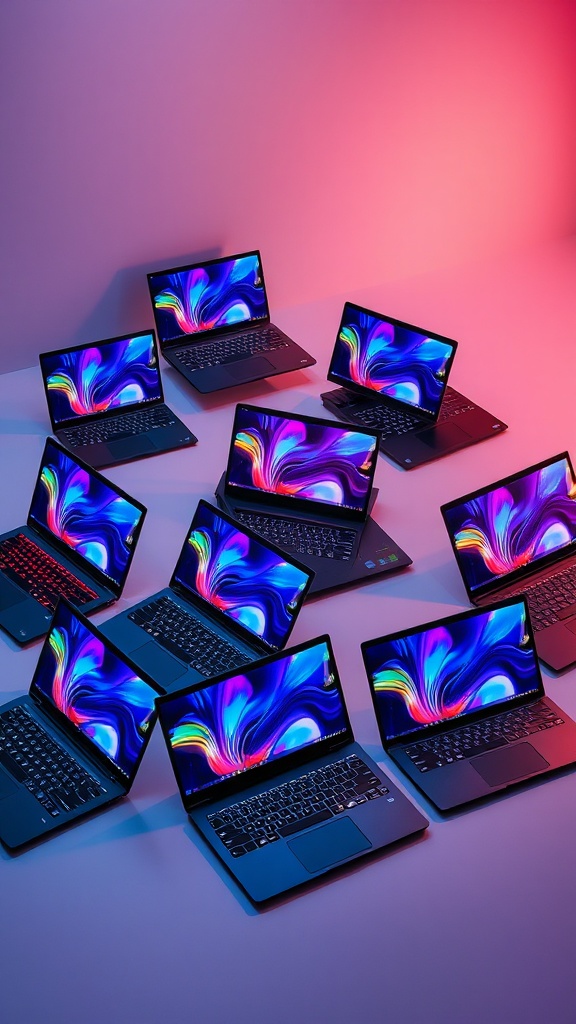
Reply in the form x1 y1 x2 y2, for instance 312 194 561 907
156 633 354 814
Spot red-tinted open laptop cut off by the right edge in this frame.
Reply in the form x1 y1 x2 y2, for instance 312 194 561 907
440 452 576 672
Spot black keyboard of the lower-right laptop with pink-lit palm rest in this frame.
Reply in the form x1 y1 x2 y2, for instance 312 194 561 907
406 700 564 772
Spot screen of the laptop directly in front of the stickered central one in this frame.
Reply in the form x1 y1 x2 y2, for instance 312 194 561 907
173 502 313 649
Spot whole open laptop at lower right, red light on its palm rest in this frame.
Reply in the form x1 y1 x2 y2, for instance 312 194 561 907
362 597 576 811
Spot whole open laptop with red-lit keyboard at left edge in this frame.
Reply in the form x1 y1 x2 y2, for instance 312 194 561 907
0 437 147 644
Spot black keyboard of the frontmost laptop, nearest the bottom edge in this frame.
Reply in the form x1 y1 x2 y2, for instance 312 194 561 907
207 754 389 857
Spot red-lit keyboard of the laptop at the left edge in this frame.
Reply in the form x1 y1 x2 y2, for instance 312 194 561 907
0 534 98 611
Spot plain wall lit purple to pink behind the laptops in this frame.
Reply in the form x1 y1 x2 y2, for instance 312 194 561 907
0 0 576 370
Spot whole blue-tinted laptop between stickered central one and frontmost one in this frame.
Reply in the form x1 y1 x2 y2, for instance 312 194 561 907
101 501 314 690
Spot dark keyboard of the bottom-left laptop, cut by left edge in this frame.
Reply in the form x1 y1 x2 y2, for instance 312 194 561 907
0 705 106 818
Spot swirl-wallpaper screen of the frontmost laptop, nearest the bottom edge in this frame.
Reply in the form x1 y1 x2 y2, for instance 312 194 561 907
159 640 348 797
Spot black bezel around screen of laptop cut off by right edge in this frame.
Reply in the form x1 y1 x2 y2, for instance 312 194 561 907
440 452 576 604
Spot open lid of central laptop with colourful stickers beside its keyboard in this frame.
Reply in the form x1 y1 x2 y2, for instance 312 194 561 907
219 404 378 522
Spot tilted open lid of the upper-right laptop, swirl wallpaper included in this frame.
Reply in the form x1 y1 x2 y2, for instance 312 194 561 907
328 302 457 423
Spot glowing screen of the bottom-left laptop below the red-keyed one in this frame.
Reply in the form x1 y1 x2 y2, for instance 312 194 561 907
31 601 158 779
